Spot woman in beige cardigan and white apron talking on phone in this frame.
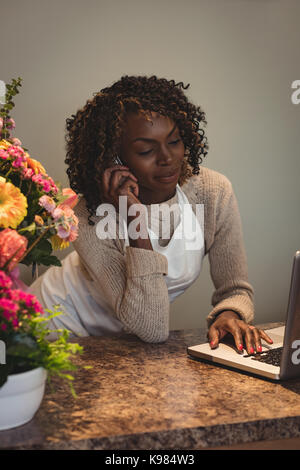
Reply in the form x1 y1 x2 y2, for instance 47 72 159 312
32 76 272 354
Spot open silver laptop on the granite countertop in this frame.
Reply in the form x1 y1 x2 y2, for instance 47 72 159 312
187 251 300 380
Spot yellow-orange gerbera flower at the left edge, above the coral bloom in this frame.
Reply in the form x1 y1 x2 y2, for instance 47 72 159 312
0 176 28 228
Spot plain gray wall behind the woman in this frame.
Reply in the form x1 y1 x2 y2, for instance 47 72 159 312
0 0 300 329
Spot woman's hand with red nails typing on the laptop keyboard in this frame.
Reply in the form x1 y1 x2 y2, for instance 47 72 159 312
207 310 273 354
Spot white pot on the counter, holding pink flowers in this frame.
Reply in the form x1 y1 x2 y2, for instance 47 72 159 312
0 367 47 430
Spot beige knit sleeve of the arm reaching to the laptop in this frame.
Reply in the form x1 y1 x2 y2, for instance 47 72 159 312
207 175 254 327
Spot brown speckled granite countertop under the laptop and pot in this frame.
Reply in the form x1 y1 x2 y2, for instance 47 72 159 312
0 323 300 450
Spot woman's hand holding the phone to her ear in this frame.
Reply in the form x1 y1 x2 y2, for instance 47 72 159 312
102 165 141 211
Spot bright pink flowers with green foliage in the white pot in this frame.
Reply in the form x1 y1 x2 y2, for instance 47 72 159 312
0 270 83 396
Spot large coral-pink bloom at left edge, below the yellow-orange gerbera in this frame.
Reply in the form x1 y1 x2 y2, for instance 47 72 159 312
0 228 28 272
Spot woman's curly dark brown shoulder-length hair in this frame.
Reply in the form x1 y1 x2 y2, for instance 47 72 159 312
65 75 208 225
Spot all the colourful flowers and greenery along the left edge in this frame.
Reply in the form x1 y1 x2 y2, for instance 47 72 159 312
0 78 82 394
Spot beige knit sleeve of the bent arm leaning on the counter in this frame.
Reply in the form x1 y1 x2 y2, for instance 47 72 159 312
73 200 170 343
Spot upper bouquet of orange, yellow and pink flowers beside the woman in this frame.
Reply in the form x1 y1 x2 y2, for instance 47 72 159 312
0 78 78 271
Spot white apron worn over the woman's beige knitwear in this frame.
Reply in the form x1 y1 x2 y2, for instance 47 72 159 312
30 185 204 336
